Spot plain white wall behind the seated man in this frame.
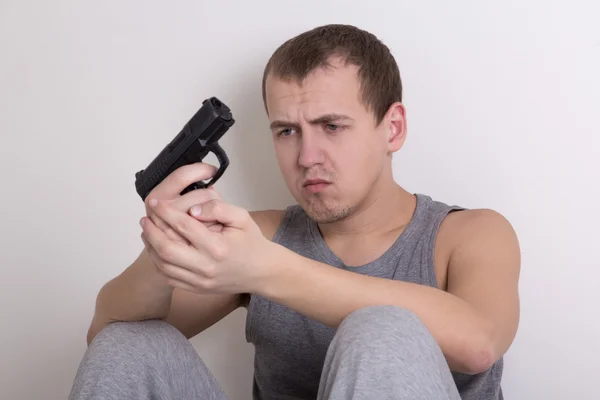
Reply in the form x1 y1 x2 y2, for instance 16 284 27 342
0 0 600 400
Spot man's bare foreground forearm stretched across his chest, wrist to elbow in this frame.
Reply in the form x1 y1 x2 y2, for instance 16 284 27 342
260 246 496 373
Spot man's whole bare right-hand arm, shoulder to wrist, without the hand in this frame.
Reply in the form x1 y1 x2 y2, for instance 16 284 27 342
262 210 520 374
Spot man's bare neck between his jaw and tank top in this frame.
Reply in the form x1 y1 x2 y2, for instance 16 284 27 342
319 180 416 237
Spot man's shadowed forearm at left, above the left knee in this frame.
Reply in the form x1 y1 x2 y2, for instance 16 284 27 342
87 253 173 344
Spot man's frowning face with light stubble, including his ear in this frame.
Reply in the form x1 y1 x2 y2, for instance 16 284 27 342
266 57 404 223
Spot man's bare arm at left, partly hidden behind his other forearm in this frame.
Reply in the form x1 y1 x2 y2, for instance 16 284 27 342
87 210 282 344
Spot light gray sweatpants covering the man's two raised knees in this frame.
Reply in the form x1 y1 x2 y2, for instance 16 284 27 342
69 306 460 400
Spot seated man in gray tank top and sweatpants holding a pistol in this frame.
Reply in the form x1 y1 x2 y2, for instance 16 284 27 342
71 25 520 400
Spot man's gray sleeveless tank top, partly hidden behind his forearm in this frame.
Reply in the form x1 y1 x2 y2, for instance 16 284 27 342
246 194 503 400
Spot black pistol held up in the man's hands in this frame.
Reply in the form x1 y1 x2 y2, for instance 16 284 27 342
135 97 235 200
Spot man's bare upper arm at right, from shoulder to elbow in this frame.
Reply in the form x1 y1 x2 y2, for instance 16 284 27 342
447 210 521 372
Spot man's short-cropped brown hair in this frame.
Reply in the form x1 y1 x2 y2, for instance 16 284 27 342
262 24 402 124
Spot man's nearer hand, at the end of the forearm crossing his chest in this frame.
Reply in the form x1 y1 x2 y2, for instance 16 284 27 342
141 196 273 293
